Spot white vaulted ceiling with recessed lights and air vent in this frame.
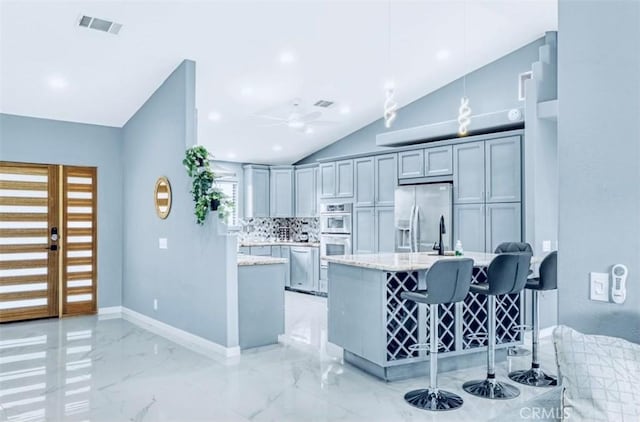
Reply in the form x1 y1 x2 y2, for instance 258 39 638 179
0 0 557 164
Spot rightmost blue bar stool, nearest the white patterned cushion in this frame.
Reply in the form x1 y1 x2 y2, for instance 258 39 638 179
509 251 558 387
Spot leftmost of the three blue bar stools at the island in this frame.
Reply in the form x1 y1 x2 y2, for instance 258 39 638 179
400 258 473 411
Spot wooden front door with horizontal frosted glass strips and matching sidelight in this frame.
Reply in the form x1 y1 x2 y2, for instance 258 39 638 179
0 162 97 322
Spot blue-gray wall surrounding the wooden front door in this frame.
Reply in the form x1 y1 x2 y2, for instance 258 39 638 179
0 114 123 307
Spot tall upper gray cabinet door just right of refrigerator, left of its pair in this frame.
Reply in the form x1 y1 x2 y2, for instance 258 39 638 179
453 142 485 204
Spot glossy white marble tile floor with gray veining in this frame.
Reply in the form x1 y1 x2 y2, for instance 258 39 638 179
0 292 559 422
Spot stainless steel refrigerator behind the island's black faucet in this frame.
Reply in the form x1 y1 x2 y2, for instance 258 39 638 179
395 183 453 252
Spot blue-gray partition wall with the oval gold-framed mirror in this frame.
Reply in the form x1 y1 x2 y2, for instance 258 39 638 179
123 61 238 346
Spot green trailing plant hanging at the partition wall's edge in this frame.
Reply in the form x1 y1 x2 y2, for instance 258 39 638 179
182 145 229 224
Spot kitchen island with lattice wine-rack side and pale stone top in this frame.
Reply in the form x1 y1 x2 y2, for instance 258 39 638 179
327 252 523 381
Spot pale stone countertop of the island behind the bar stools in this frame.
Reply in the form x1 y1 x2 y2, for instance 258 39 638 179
325 252 540 272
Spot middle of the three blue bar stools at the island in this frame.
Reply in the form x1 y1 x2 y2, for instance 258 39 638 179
462 252 531 400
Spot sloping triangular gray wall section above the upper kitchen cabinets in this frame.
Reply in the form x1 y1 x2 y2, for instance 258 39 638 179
296 38 544 164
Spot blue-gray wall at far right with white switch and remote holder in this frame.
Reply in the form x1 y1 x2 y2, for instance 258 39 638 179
558 0 640 342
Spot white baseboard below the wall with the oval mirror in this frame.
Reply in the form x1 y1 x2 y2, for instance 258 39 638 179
122 306 240 357
